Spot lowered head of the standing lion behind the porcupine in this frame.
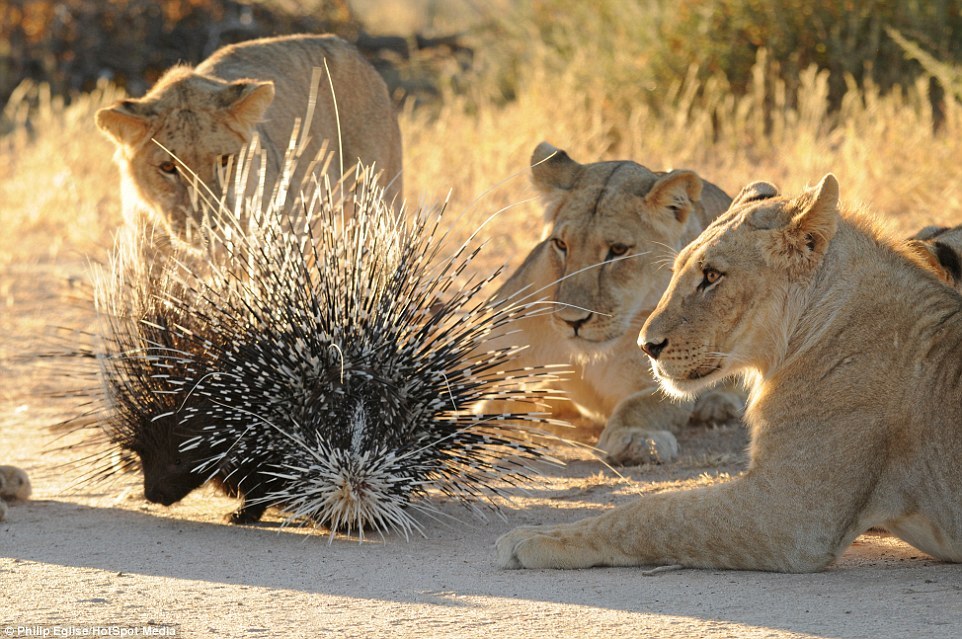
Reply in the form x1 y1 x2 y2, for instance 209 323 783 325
96 67 274 233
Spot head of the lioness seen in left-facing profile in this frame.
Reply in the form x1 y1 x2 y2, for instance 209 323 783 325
638 174 838 396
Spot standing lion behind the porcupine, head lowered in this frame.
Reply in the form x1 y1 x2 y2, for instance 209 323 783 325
96 35 403 237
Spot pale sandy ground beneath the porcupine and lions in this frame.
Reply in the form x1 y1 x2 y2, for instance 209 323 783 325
0 260 962 638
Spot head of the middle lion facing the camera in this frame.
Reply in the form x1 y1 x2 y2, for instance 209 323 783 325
531 142 729 350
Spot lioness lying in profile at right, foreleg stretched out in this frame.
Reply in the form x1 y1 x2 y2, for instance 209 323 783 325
497 175 962 572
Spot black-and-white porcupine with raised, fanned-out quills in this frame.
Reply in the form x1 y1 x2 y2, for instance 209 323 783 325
86 159 568 536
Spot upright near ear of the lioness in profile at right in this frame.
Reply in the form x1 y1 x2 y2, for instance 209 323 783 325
774 173 838 274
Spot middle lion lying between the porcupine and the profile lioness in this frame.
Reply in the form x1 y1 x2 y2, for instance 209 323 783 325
495 142 742 464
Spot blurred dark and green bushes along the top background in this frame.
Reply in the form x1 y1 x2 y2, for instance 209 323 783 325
0 0 962 108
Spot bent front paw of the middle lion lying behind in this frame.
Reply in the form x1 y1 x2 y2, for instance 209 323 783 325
597 387 693 466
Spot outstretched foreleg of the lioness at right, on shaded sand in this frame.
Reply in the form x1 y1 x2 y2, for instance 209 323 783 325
497 474 858 572
